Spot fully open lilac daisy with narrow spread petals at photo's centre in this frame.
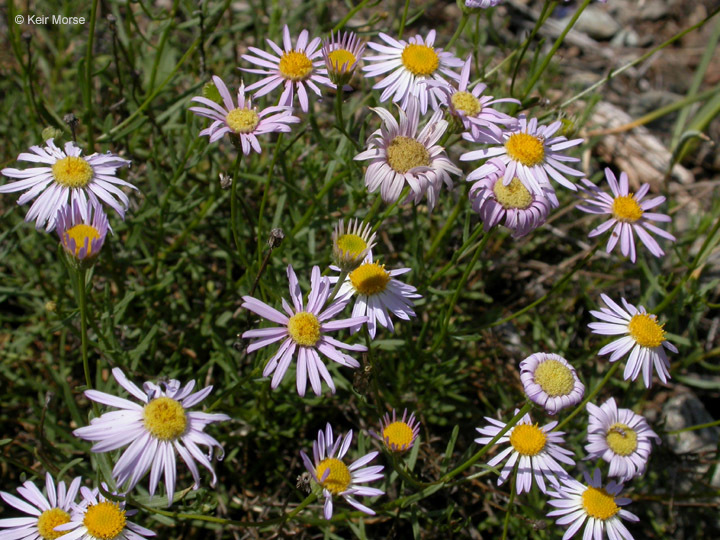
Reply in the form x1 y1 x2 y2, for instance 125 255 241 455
242 266 367 396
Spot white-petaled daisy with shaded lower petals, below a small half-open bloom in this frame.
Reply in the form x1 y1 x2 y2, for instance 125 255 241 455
330 253 422 338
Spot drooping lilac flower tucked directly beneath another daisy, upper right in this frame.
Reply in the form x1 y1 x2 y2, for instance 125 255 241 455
467 159 551 238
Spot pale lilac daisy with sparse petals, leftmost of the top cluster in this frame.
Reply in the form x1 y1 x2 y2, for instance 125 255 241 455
189 75 300 156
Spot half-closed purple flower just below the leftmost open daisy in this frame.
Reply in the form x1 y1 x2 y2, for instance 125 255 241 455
55 201 109 261
